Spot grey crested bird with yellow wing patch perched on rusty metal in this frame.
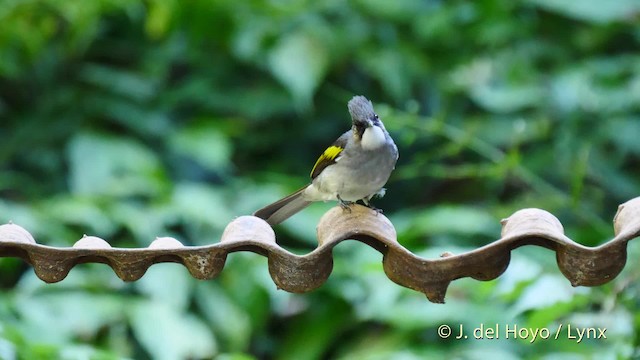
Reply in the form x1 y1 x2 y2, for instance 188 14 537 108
253 96 398 225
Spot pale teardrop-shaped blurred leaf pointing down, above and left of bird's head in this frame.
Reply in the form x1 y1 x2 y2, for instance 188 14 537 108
268 32 329 108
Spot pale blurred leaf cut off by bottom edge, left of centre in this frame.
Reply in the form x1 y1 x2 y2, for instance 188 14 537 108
127 300 217 360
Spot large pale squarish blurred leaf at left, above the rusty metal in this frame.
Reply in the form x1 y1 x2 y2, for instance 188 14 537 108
67 133 164 196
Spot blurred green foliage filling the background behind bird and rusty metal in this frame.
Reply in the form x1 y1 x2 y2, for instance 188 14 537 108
0 0 640 359
